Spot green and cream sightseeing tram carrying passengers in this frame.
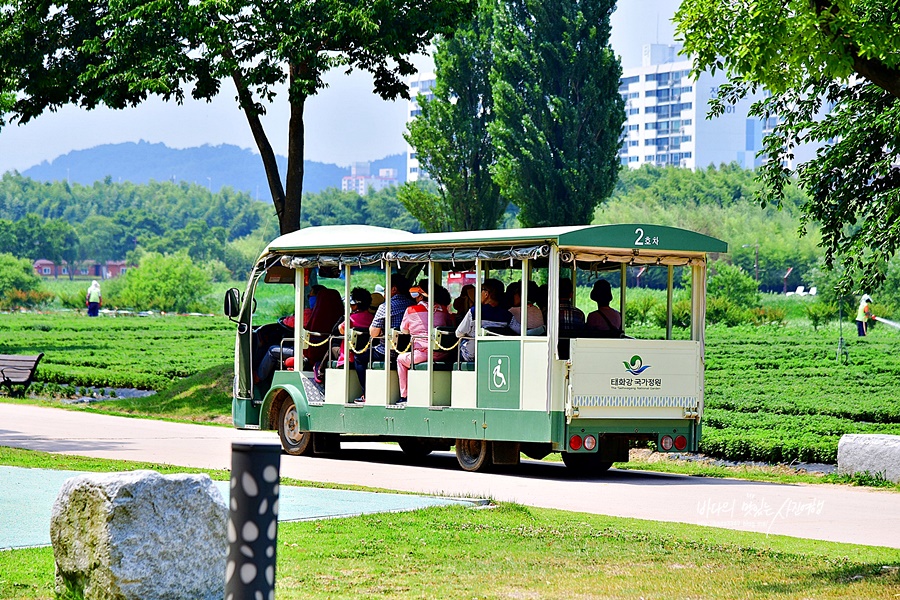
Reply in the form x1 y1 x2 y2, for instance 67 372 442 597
225 224 727 472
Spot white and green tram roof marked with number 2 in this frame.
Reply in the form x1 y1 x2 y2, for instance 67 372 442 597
264 223 728 254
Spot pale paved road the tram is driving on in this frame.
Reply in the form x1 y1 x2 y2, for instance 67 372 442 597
0 404 900 548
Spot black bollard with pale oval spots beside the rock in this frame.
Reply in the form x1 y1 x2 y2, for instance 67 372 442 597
225 442 281 600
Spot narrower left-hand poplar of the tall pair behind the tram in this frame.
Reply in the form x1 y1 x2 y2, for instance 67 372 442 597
398 0 508 231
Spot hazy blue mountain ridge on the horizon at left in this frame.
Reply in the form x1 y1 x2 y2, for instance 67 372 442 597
22 141 406 199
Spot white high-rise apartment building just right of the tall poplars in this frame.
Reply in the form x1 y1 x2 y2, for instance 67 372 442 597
619 44 764 169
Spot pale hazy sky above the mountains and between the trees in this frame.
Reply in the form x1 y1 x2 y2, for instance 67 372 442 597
0 0 679 173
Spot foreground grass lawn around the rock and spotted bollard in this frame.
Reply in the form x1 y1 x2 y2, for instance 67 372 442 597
0 504 900 600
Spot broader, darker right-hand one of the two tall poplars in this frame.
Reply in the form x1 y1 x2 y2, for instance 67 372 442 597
489 0 625 227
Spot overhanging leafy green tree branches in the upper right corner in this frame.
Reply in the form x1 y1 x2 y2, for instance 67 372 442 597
675 0 900 289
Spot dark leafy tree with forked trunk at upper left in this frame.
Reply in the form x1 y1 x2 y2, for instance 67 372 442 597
0 0 473 233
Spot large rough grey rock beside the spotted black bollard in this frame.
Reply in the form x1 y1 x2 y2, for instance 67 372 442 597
50 471 228 600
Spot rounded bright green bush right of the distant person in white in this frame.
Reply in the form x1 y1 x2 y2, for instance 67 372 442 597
108 252 211 312
